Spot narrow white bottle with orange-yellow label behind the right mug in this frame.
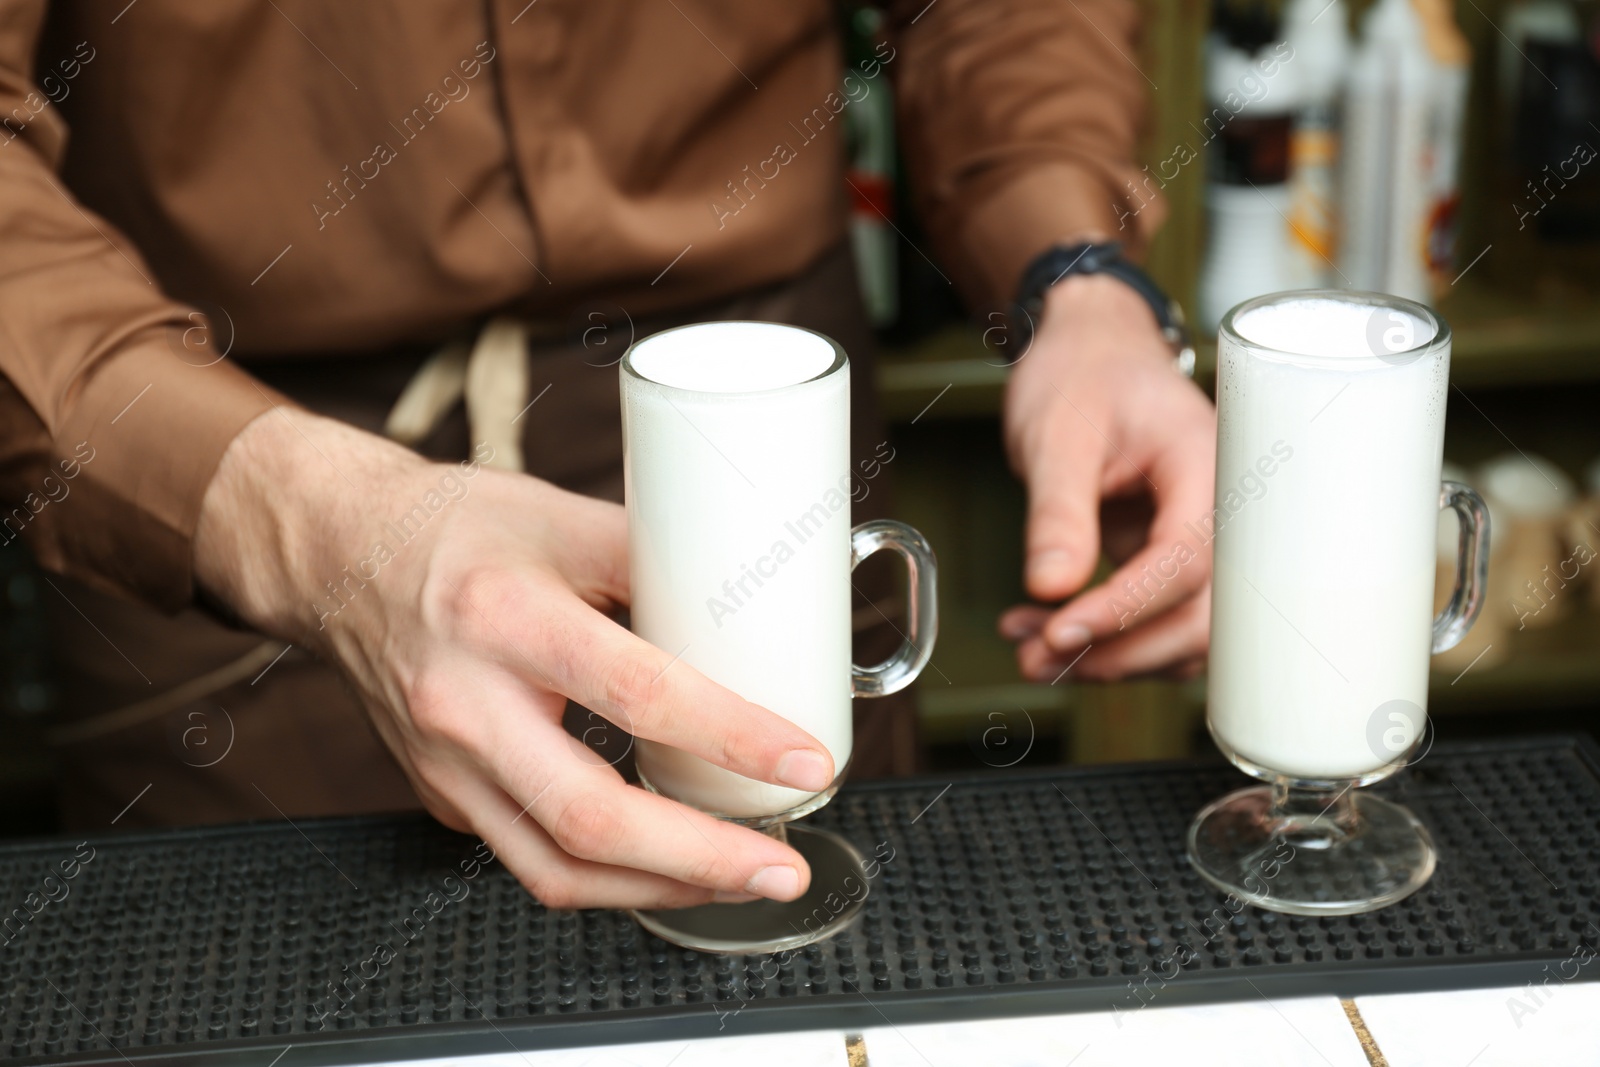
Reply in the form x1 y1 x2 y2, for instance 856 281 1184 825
1283 0 1350 290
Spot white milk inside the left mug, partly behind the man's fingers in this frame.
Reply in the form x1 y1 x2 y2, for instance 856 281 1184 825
622 323 851 817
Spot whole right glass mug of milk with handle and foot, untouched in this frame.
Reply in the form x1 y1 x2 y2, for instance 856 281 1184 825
1189 291 1490 915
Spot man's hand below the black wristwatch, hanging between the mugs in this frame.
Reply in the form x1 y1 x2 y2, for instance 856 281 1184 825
1000 275 1216 681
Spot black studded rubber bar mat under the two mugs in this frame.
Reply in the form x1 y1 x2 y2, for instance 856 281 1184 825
0 737 1600 1067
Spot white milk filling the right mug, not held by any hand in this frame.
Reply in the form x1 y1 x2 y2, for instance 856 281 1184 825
1210 298 1450 777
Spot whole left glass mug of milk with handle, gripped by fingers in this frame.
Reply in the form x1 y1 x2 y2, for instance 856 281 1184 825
621 322 938 952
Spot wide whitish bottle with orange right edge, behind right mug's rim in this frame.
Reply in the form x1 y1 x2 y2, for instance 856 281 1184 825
1339 0 1469 301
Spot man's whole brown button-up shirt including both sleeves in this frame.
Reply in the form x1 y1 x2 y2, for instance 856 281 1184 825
0 0 1155 608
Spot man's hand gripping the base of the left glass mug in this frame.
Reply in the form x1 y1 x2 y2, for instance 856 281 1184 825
195 408 834 909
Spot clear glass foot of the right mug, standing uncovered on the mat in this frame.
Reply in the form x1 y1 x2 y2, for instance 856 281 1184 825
1189 781 1435 915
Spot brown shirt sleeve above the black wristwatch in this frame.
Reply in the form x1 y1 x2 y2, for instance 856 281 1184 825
888 0 1165 307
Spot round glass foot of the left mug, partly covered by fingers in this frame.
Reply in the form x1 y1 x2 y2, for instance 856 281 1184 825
630 824 869 955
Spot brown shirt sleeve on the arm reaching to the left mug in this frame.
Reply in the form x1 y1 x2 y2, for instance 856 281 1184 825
0 0 283 609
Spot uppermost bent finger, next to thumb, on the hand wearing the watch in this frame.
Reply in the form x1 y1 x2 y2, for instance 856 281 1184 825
1045 413 1213 653
